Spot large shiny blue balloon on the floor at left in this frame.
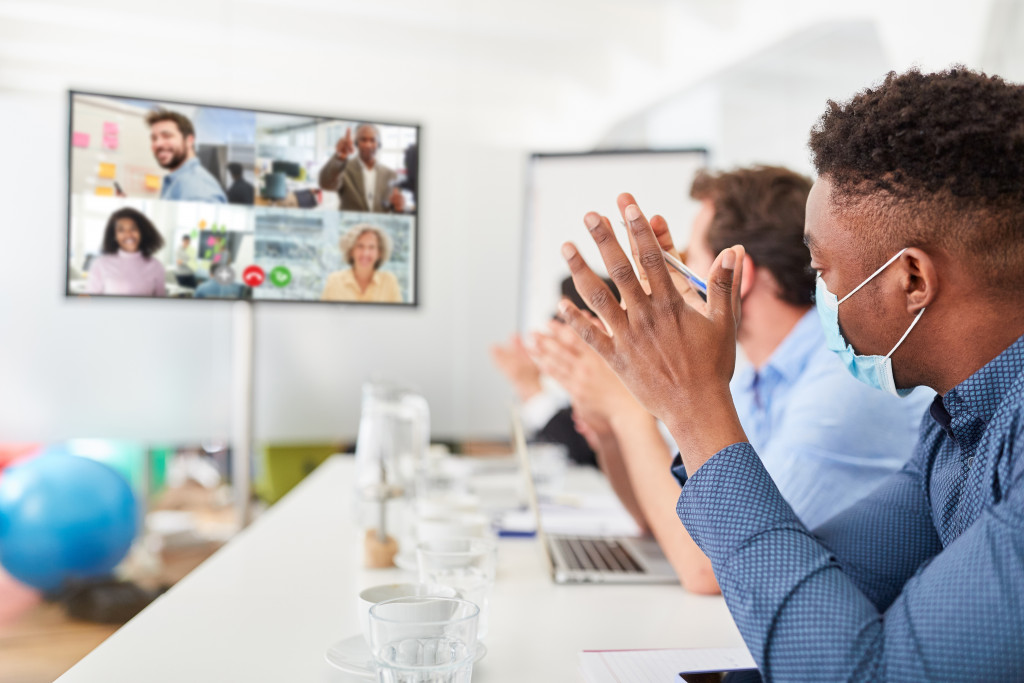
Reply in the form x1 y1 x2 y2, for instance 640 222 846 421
0 454 138 591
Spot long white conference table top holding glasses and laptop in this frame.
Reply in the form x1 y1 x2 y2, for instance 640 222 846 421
58 456 742 683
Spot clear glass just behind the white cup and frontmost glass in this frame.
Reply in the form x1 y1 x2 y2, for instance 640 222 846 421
416 538 498 640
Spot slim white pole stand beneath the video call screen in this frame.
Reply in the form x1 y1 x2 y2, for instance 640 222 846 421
231 301 255 528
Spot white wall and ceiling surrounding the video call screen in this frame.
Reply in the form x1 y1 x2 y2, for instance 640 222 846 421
0 0 1024 440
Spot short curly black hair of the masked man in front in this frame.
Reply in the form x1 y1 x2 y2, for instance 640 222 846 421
810 66 1024 289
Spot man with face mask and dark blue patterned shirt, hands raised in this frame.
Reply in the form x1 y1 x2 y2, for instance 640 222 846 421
563 67 1024 681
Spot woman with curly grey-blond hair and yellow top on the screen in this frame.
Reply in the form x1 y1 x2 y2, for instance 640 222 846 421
321 223 401 303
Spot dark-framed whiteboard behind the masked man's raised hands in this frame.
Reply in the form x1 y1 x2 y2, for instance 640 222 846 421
519 150 708 333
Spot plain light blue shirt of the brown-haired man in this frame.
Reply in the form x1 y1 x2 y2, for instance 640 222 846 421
729 308 935 527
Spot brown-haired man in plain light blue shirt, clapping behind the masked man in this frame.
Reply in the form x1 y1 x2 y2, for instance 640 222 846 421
536 167 931 593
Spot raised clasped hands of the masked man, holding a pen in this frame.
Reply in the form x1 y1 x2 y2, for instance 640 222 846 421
559 195 745 472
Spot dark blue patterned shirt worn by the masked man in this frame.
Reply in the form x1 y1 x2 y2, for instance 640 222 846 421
677 337 1024 681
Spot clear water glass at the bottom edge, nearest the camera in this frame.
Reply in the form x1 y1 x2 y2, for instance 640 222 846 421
370 597 480 683
